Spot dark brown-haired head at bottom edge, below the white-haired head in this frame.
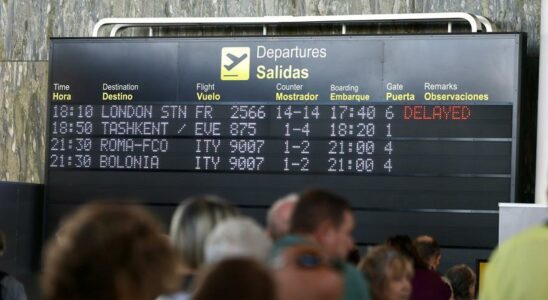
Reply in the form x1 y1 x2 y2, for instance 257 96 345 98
192 258 277 300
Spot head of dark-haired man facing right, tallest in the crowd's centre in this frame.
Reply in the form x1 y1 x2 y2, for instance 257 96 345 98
290 189 354 259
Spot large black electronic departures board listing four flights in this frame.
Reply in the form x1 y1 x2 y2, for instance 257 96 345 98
46 34 523 230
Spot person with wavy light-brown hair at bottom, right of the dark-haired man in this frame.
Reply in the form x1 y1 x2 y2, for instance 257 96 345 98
358 245 413 300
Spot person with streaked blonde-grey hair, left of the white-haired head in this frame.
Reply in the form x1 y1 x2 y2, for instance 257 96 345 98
160 195 239 300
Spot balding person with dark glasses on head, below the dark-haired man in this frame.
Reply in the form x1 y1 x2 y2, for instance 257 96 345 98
272 245 344 300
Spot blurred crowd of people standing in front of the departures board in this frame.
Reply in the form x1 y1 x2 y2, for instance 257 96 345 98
0 189 547 300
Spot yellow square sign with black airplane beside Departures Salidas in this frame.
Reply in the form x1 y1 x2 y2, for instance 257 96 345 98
220 47 251 80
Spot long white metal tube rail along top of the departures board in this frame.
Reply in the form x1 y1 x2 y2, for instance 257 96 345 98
92 12 493 37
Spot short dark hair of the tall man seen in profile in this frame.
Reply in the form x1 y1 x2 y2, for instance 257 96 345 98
290 189 352 234
